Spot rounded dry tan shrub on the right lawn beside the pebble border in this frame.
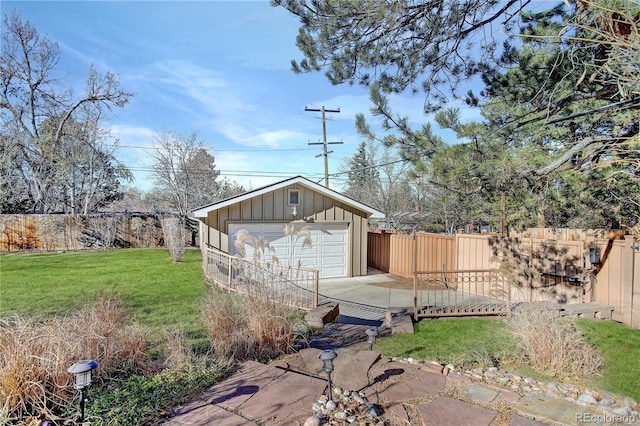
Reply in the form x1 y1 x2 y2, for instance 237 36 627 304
508 306 604 377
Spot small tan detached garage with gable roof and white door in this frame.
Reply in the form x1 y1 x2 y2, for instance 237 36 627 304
191 176 383 278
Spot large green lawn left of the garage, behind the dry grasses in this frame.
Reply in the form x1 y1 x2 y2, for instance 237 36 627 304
0 249 206 341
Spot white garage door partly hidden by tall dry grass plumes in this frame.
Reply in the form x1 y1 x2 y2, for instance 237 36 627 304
229 223 348 278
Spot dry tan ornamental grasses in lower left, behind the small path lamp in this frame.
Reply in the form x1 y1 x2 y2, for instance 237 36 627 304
0 299 146 419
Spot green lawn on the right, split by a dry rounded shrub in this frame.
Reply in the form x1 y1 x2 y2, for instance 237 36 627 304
375 318 640 401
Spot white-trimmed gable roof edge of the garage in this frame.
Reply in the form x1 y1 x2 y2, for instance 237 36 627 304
189 176 384 218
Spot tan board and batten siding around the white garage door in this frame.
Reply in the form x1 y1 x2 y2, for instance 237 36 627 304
200 184 368 276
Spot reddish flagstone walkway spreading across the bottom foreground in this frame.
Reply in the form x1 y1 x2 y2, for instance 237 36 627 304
164 324 640 426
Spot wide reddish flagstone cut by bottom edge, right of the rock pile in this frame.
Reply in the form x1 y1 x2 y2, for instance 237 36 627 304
418 397 498 426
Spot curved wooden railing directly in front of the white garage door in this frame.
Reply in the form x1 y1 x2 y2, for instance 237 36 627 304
204 247 319 310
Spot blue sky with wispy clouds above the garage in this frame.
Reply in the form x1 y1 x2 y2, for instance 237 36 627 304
1 0 480 190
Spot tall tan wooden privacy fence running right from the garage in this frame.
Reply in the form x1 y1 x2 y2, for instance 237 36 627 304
369 230 640 328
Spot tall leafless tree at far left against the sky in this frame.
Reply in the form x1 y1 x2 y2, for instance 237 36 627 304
0 12 132 213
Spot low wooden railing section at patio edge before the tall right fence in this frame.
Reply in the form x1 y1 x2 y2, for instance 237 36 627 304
413 269 511 321
